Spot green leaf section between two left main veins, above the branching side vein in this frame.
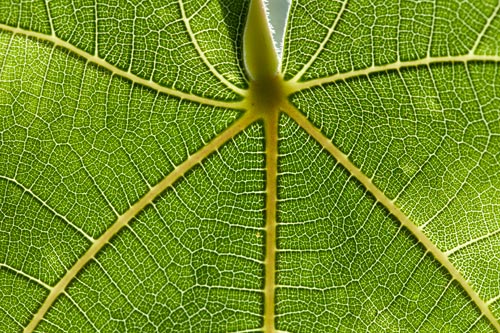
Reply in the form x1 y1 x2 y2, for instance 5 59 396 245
0 30 239 237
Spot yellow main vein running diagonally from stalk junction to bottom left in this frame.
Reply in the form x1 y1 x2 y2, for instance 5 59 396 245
24 113 256 333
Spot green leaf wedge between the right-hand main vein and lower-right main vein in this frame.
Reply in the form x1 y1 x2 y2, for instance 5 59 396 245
293 63 500 306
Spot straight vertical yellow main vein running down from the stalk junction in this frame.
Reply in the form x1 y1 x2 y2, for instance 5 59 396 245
264 110 279 333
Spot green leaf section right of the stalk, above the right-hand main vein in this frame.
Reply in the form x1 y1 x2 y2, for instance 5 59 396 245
282 0 500 80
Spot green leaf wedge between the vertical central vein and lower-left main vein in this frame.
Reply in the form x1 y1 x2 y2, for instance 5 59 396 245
37 124 265 332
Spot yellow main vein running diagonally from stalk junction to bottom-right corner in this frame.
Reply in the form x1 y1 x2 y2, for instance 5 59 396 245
283 103 500 332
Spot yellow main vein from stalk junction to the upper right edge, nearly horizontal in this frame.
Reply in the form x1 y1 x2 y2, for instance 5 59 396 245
287 54 500 94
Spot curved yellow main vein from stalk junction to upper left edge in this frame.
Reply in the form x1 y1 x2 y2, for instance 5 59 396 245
0 23 244 109
